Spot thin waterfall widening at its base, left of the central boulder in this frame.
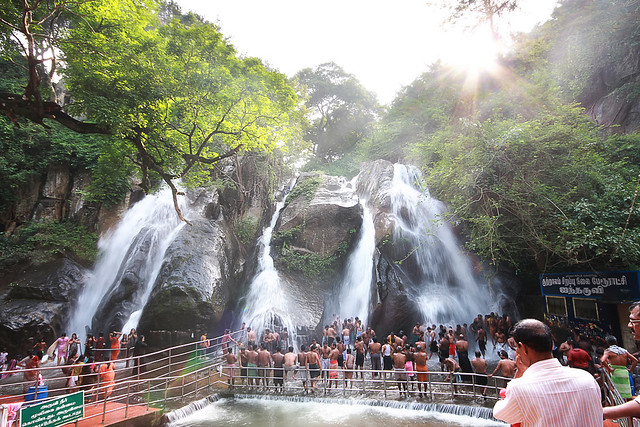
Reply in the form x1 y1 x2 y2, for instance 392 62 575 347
242 187 296 343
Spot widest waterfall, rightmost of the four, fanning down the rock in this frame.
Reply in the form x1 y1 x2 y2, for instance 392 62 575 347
388 164 495 324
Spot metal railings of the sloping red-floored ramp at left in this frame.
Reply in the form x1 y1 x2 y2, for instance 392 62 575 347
0 331 242 422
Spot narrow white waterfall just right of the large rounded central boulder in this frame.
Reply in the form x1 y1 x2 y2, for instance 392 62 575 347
339 200 376 325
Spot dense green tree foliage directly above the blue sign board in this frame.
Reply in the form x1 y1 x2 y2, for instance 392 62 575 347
423 106 640 271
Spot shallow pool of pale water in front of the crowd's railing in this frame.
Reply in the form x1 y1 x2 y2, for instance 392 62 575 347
168 396 505 427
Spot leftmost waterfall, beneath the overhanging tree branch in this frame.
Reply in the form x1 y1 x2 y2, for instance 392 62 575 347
67 189 191 342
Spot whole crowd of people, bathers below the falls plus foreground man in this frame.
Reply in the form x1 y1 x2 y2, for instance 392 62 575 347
0 302 640 426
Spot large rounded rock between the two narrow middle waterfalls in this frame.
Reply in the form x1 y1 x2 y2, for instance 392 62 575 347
260 174 362 329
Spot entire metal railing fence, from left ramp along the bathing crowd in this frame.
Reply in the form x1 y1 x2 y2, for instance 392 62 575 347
0 331 633 426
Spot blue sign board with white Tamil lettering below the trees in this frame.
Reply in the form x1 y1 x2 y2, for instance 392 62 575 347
540 271 640 302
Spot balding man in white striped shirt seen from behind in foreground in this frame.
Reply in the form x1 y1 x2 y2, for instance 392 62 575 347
493 319 602 427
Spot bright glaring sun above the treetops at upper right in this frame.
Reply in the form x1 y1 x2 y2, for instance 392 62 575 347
440 29 500 72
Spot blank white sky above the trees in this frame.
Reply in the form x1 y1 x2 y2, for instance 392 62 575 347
172 0 557 104
